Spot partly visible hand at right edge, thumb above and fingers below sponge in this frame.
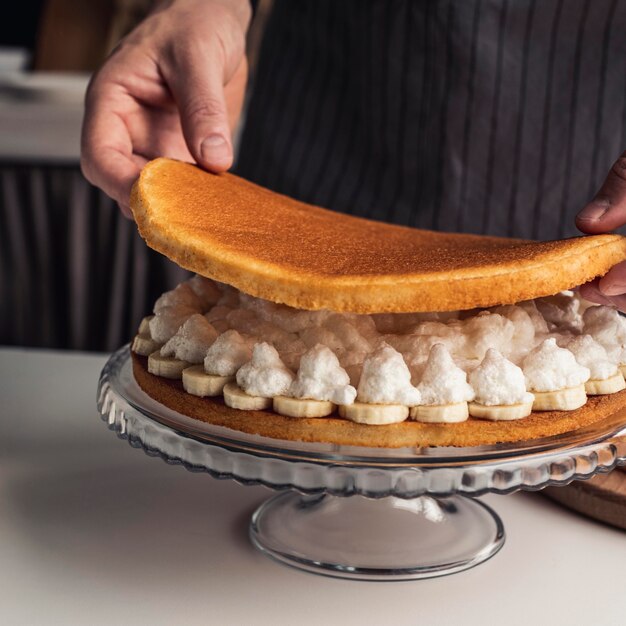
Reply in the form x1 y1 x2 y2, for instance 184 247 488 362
576 152 626 311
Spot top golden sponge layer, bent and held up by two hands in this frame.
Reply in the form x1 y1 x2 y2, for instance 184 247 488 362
131 159 626 313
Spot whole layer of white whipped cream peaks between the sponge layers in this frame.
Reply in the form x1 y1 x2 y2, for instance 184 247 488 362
149 275 626 406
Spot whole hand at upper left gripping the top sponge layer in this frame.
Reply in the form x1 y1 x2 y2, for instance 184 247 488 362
81 0 251 217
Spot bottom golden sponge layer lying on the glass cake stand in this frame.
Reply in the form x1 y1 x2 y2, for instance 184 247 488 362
131 353 626 448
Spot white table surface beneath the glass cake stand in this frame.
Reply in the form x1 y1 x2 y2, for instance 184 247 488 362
0 349 626 626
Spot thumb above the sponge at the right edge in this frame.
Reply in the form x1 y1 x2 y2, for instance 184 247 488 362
576 152 626 234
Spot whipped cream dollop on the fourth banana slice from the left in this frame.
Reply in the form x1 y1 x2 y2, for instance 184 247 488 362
237 342 295 398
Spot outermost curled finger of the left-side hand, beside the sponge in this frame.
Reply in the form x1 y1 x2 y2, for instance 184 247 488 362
81 79 140 207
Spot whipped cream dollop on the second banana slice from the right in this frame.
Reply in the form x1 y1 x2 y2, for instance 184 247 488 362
522 337 591 391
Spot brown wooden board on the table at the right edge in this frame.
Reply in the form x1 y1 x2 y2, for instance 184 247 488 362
543 467 626 530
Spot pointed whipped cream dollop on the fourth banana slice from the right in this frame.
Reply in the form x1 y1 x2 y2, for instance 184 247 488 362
417 343 474 405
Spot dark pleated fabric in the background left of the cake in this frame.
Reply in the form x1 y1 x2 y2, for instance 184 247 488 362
0 164 189 351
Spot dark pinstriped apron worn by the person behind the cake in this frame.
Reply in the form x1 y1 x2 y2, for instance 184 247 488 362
236 0 626 239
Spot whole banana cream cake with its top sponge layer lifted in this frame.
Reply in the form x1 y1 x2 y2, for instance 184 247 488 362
131 159 626 448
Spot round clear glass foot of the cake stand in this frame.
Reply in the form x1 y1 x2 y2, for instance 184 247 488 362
250 492 505 581
